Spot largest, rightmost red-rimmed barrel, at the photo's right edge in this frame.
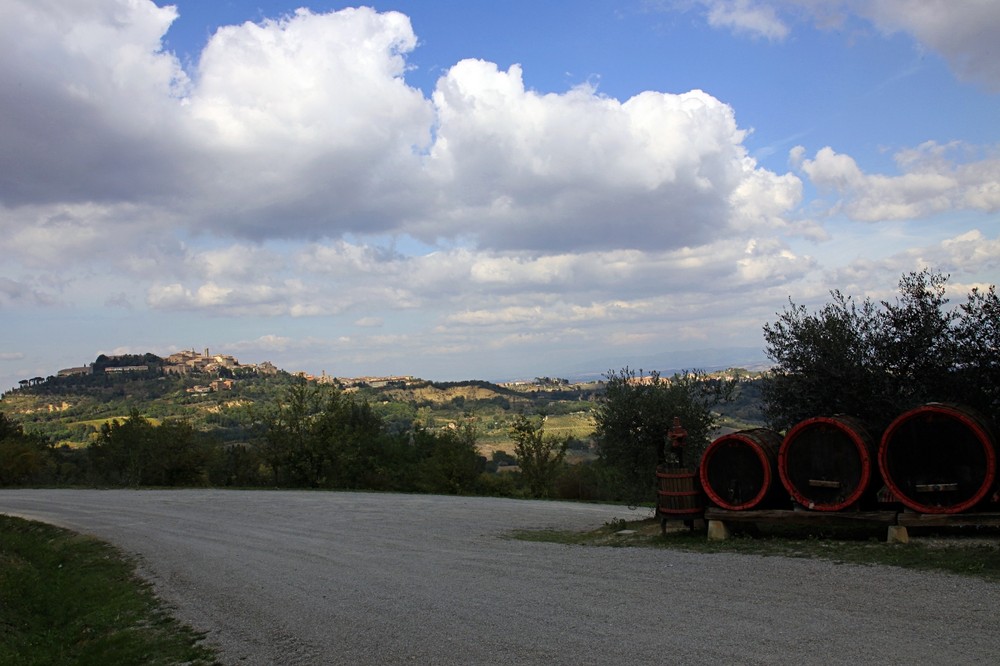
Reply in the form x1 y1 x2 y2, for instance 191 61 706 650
878 403 997 513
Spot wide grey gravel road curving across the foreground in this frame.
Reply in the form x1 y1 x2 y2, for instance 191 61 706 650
0 490 1000 666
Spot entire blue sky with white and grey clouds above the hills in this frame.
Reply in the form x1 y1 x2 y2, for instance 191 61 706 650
0 0 1000 390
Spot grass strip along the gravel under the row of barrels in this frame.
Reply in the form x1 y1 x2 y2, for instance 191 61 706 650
512 519 1000 582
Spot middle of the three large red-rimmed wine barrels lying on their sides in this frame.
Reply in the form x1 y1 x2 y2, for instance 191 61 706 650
778 415 878 511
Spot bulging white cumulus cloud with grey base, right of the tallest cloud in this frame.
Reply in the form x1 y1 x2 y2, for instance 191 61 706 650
415 60 797 250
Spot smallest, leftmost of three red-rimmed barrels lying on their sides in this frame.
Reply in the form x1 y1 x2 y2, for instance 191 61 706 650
701 428 781 511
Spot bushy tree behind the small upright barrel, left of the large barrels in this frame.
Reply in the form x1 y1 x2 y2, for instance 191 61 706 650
594 367 735 501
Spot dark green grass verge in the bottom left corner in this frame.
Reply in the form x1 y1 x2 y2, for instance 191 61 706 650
0 515 216 666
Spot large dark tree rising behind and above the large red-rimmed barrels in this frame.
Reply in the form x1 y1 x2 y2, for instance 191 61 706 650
762 269 1000 429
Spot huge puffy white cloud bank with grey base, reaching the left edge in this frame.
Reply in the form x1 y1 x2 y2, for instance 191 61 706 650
0 0 798 250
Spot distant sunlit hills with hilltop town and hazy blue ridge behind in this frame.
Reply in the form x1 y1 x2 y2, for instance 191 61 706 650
0 349 762 449
